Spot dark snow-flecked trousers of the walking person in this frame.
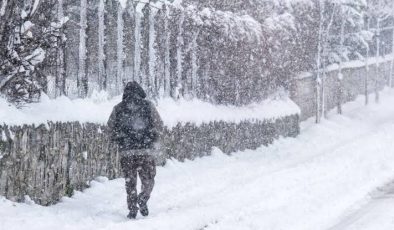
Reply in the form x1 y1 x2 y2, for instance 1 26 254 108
120 155 156 210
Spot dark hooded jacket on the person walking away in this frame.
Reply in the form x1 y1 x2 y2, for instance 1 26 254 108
108 82 163 151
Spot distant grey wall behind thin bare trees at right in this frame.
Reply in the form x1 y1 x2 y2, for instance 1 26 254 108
291 59 391 121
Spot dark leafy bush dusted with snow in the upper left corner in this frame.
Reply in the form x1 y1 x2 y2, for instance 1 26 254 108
0 0 66 104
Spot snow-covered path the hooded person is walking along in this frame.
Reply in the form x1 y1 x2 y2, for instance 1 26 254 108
0 91 394 230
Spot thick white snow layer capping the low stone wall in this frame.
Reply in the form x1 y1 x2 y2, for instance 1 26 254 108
0 92 300 128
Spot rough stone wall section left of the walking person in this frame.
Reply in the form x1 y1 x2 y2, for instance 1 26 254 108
0 122 119 205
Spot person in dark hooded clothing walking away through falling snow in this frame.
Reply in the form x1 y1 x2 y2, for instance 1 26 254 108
108 81 163 219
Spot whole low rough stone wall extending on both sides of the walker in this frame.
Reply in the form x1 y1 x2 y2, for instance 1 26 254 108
0 115 299 205
